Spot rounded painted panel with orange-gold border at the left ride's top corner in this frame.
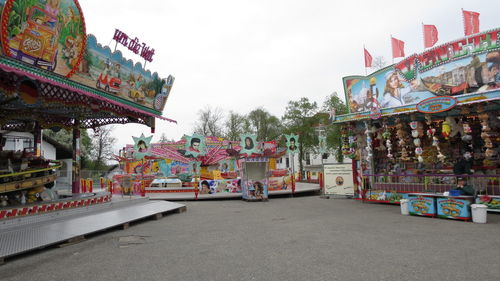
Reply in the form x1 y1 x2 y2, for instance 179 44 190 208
1 0 87 77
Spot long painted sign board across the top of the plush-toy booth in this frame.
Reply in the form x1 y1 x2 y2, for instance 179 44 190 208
343 29 500 113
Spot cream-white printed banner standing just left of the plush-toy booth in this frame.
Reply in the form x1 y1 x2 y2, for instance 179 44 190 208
323 163 354 195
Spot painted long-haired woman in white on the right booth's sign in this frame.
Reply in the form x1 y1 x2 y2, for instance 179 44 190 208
382 72 413 107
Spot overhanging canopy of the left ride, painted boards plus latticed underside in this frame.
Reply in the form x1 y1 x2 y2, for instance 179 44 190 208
0 0 175 130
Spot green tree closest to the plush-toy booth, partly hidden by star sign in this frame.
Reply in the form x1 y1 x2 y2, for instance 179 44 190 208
323 92 348 162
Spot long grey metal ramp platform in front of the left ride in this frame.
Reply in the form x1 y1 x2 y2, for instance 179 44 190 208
0 198 186 264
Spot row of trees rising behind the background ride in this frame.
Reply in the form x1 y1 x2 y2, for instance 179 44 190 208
192 93 347 171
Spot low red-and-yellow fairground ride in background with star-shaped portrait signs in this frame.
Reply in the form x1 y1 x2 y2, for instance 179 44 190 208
113 134 292 200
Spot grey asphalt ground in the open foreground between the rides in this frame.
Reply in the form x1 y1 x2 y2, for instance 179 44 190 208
0 196 500 281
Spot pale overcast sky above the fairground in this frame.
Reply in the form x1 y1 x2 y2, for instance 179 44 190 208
80 0 500 151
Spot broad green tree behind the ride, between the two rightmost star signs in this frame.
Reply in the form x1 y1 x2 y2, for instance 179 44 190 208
282 97 319 174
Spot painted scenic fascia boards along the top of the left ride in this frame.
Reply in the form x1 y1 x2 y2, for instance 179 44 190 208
0 0 174 114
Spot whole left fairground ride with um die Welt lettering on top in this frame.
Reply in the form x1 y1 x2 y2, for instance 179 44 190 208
0 0 175 219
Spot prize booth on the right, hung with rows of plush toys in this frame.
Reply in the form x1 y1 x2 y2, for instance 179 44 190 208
335 29 500 220
